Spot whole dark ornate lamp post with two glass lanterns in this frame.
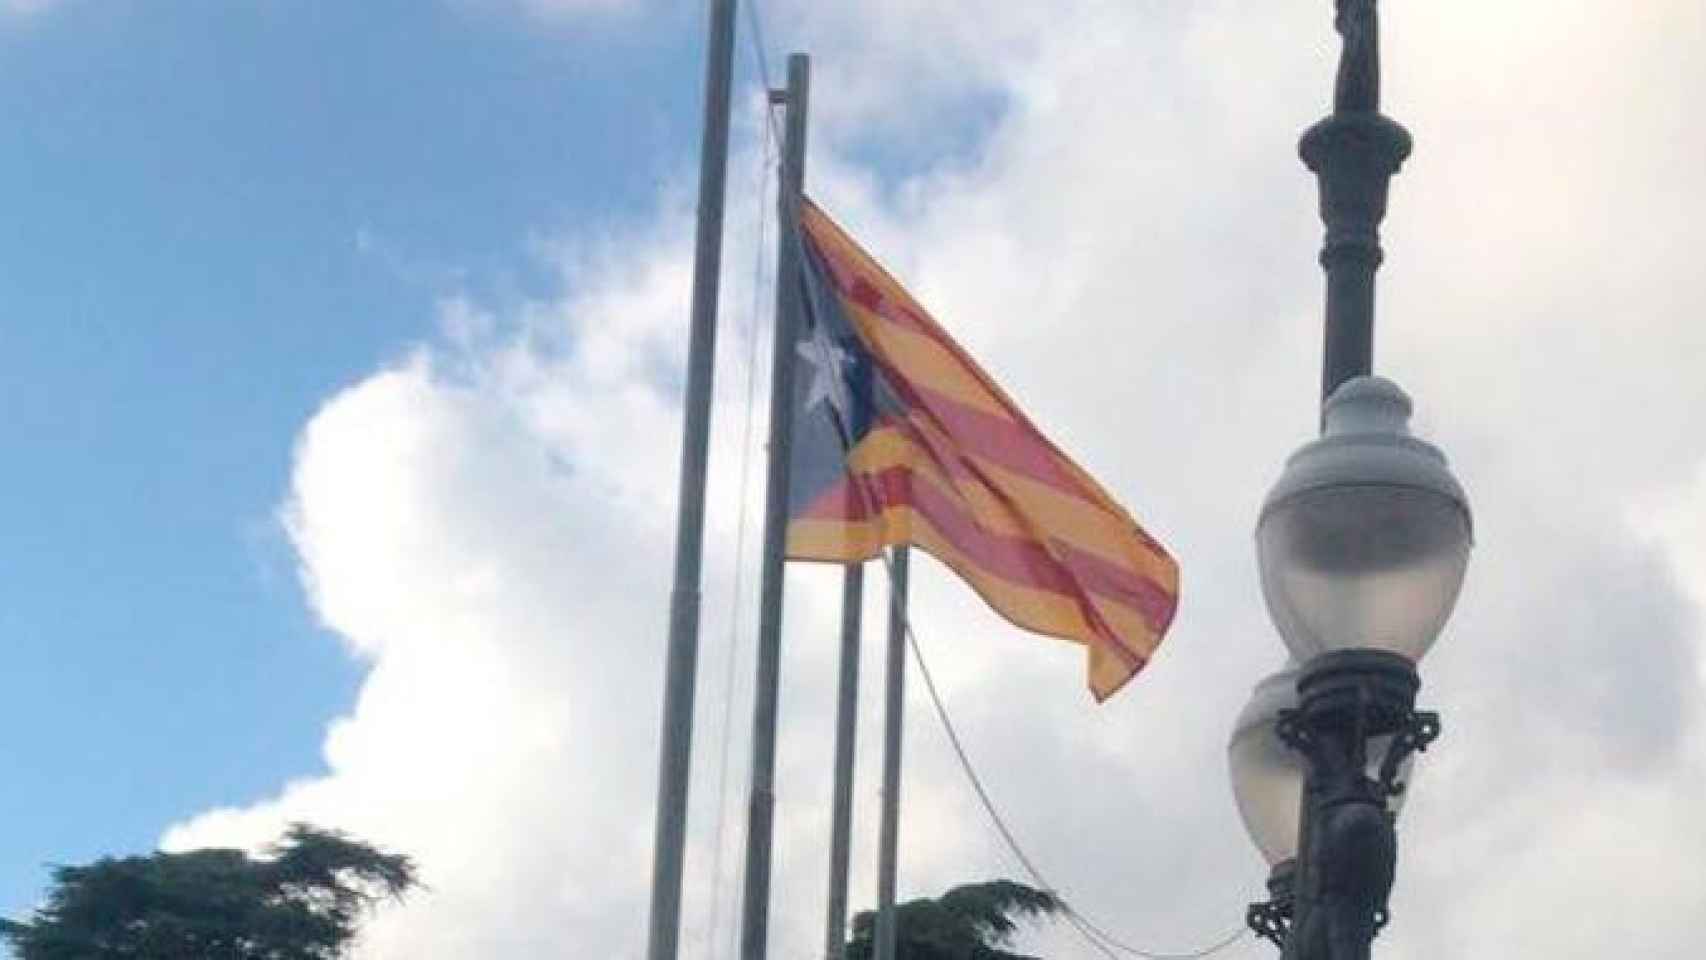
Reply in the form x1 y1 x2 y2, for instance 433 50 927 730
1228 0 1472 960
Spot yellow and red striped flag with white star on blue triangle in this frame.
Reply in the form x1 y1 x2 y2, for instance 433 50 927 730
788 201 1179 701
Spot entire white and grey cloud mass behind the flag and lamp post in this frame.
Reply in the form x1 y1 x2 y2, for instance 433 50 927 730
167 0 1706 960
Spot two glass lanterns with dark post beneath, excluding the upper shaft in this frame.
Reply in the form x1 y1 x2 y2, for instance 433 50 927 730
1230 377 1471 960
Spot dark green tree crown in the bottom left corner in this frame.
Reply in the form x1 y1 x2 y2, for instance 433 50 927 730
0 824 420 960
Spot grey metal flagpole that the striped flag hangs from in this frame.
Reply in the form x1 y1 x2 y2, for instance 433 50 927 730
740 53 810 960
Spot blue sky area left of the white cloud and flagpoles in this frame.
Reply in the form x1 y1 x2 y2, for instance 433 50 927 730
0 0 699 914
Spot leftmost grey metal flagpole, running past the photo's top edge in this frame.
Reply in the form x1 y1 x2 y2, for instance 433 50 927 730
647 0 735 960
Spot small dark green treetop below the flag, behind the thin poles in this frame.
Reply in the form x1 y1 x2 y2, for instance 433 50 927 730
846 880 1061 960
